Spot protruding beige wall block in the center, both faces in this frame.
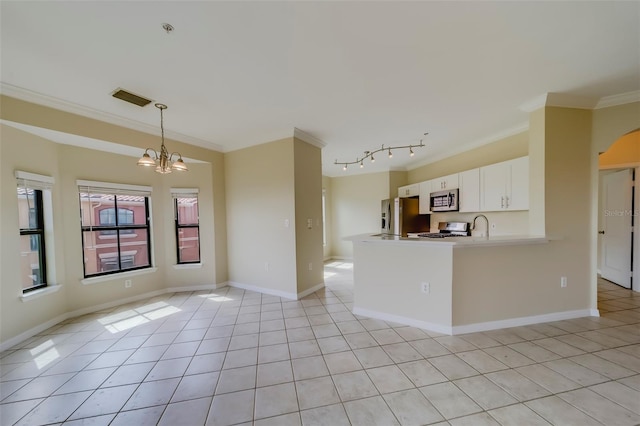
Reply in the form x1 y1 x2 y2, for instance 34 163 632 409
225 138 324 297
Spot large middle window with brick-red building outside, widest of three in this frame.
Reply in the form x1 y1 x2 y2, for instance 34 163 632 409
78 181 151 278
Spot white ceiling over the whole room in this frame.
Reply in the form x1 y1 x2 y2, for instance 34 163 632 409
0 1 640 176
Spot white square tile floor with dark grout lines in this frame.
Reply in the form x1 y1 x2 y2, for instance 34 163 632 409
0 262 640 426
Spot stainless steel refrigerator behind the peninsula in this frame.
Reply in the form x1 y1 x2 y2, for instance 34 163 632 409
381 198 431 237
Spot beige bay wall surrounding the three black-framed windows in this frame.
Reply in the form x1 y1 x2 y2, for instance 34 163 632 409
0 121 226 342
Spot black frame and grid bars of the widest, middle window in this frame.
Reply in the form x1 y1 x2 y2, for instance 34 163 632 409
78 189 153 278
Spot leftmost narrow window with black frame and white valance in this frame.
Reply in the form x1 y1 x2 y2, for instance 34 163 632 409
15 171 53 293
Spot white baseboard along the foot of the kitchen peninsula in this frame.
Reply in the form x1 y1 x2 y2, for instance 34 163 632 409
353 306 600 335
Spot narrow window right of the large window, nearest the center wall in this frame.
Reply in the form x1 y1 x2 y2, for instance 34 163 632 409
171 188 200 264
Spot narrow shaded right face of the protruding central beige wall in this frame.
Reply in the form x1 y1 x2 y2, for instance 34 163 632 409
293 139 324 293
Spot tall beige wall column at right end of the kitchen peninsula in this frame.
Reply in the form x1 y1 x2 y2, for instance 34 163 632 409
534 107 597 309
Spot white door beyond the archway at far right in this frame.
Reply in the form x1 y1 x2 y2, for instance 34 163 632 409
600 169 633 288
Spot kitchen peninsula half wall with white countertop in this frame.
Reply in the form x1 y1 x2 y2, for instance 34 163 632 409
347 234 598 335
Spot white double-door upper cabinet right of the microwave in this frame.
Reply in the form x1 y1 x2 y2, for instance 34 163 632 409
480 157 529 212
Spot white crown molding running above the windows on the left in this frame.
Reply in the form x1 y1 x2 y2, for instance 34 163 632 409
0 82 224 152
